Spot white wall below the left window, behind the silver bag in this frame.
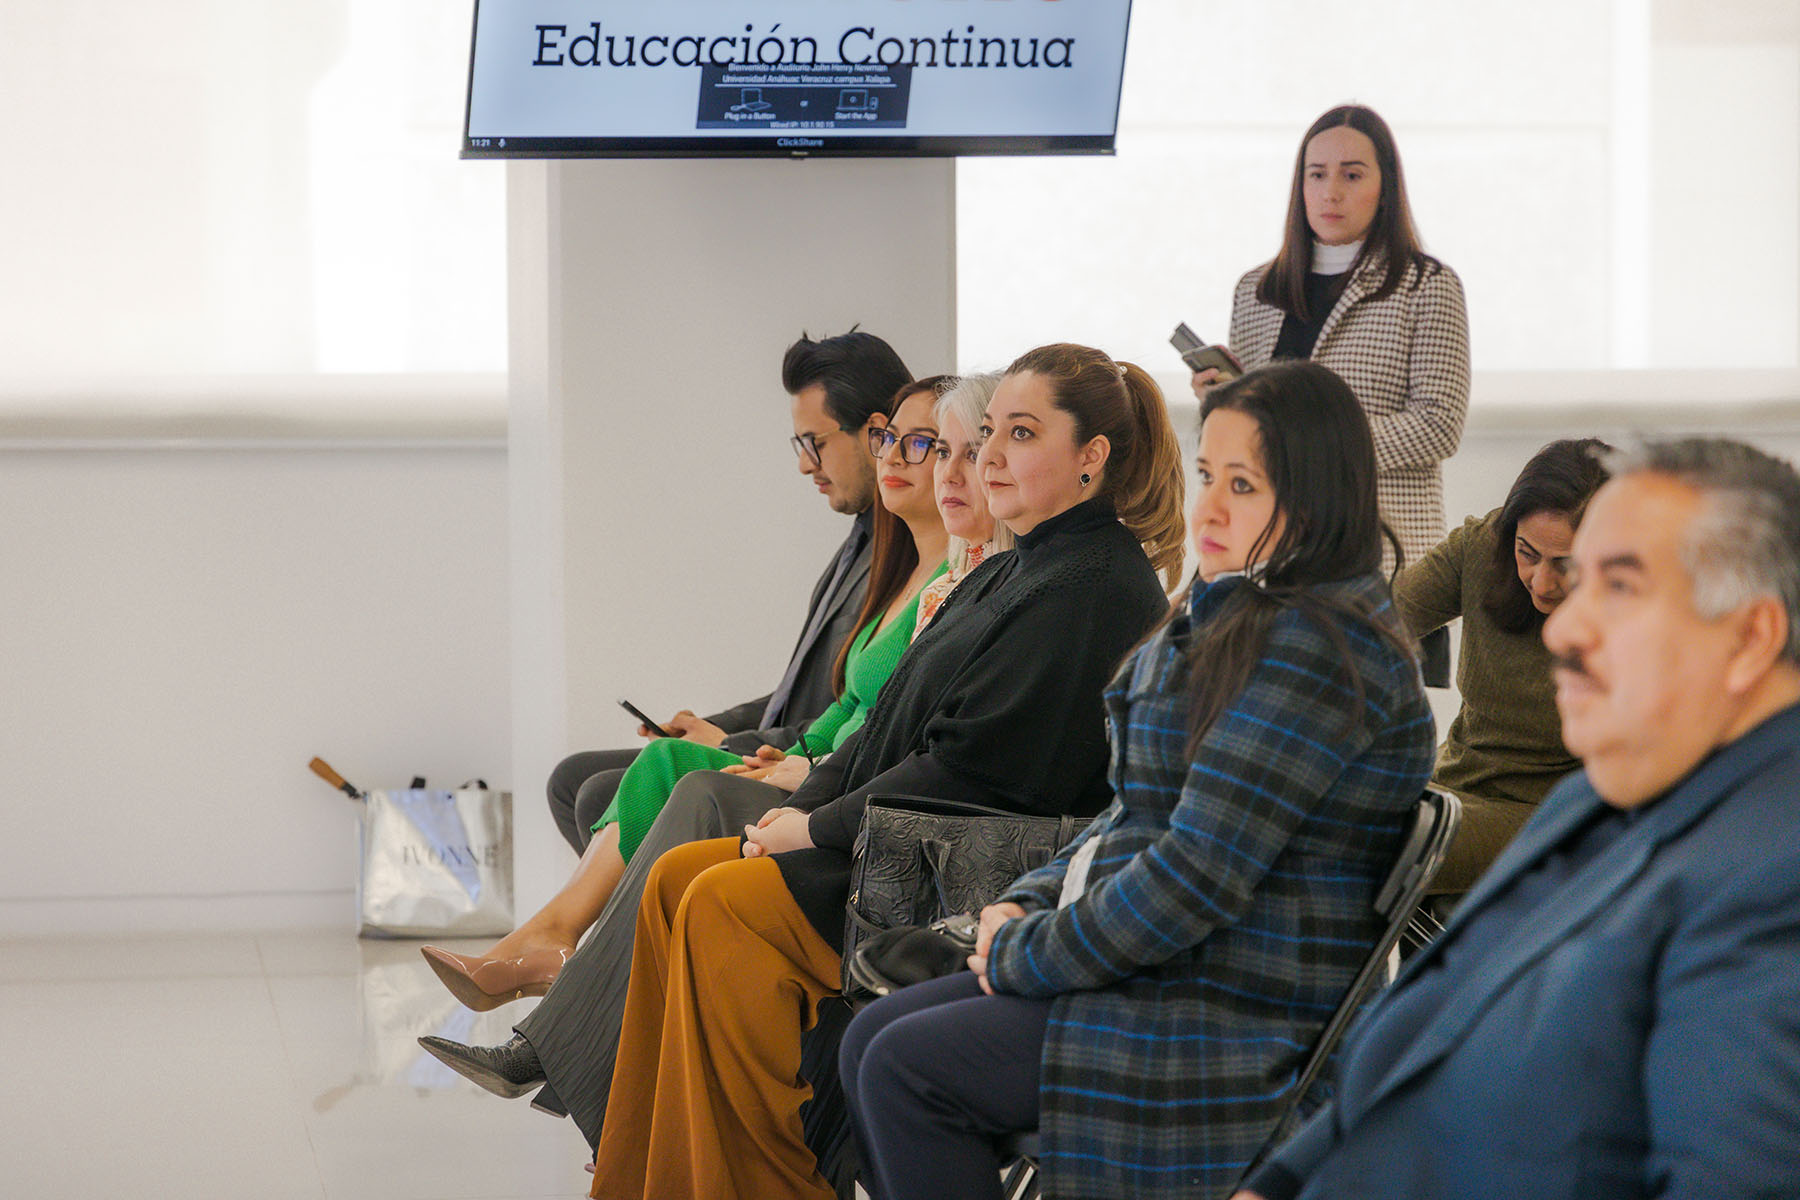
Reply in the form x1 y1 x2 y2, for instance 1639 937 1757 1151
0 439 511 936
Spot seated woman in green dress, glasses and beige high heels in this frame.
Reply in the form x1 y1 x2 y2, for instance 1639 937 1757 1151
421 376 950 1011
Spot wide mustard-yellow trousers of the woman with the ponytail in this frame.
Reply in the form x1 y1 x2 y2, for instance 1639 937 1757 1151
590 838 841 1200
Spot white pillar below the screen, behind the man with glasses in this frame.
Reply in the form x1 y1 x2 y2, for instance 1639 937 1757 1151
508 158 956 914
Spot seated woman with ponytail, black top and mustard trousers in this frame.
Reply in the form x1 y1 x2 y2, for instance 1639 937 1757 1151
594 345 1183 1200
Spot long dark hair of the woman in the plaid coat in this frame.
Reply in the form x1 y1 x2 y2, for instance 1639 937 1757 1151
1177 362 1413 752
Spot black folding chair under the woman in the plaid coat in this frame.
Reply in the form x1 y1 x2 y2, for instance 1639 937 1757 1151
1001 788 1462 1200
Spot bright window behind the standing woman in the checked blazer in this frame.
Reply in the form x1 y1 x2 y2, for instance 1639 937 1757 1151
958 0 1800 374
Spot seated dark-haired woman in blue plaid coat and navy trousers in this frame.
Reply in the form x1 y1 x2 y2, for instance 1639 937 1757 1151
839 362 1431 1200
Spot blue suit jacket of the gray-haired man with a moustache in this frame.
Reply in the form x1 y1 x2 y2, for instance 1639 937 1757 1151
1251 705 1800 1200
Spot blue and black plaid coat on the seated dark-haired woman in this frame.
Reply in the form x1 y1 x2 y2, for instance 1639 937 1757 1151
988 576 1435 1200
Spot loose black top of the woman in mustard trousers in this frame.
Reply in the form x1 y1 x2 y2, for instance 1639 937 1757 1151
776 500 1168 948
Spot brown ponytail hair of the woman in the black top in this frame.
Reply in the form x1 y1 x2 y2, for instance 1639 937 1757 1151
1006 342 1188 590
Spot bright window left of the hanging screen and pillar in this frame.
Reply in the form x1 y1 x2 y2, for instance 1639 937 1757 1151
0 0 506 378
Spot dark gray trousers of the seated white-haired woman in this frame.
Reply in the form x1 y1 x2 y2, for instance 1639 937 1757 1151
517 770 788 1148
